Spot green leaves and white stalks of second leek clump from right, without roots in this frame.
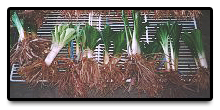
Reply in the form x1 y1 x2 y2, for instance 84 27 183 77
156 22 180 71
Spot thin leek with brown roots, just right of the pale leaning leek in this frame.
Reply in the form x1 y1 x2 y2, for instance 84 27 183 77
55 24 93 98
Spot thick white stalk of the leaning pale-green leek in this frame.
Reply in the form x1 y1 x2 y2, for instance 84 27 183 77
44 44 63 66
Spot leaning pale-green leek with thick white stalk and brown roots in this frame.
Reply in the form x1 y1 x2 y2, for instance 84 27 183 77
18 25 75 86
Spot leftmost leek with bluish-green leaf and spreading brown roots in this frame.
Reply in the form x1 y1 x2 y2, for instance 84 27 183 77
10 12 51 66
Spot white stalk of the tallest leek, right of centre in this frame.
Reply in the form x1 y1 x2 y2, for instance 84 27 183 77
131 31 141 55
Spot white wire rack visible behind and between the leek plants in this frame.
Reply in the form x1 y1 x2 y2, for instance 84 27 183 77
10 12 197 82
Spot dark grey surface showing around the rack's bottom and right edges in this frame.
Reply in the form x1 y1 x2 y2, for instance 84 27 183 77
8 10 213 98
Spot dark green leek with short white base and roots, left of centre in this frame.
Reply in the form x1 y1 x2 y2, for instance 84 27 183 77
72 24 102 94
